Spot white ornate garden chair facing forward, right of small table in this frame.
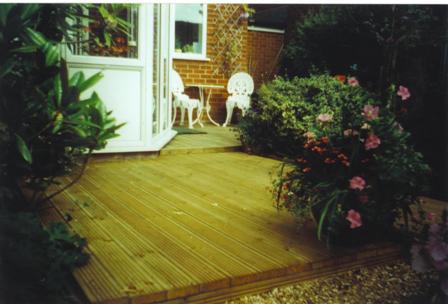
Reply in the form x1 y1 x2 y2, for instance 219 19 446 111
222 72 254 127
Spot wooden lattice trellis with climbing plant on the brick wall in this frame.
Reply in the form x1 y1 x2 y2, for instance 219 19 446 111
213 4 245 76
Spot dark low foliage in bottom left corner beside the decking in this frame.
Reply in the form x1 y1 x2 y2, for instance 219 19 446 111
0 212 89 303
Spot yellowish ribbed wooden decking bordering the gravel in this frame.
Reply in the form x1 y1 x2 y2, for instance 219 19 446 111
42 126 399 303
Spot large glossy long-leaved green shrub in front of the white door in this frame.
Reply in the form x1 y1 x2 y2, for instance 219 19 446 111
0 4 121 204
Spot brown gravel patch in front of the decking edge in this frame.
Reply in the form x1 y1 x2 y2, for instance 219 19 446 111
227 261 437 304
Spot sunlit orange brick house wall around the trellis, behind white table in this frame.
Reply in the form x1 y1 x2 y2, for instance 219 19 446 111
173 4 248 123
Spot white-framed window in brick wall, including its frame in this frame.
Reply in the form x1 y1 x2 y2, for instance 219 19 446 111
173 4 207 59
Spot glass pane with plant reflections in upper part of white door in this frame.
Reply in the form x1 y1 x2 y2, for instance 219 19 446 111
74 4 138 58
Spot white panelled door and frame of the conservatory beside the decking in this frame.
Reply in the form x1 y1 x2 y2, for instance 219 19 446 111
66 4 175 153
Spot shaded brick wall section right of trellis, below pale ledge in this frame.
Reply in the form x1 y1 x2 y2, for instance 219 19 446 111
247 30 284 88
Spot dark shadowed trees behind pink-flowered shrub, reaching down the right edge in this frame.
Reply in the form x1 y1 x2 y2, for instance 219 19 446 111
282 5 448 200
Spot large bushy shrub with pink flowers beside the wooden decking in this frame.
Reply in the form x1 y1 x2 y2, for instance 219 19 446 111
273 75 429 244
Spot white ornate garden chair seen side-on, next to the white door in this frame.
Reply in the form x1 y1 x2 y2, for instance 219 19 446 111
171 70 202 129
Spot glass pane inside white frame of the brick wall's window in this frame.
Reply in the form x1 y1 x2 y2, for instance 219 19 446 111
174 4 204 54
